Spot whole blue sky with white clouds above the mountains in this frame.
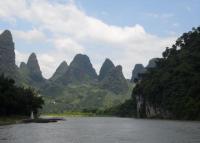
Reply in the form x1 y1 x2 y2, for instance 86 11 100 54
0 0 200 78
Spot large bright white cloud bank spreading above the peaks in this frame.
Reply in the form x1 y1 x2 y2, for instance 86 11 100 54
0 0 176 78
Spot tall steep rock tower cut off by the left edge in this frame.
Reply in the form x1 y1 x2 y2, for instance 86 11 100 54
0 30 17 78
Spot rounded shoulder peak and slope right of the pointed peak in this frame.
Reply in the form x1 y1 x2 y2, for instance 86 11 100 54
101 66 128 94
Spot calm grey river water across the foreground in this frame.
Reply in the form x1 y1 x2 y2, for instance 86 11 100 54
0 117 200 143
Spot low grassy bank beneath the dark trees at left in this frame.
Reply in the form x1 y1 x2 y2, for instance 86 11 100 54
0 116 27 126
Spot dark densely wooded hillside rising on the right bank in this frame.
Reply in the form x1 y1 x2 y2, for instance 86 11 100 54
133 27 200 119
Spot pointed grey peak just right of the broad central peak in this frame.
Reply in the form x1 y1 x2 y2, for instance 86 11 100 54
98 59 115 81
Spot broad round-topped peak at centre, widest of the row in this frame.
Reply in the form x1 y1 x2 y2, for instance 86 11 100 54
58 54 97 84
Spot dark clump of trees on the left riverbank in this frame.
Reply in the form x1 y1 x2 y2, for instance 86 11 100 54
0 75 44 116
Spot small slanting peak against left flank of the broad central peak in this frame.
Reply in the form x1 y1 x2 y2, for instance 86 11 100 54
50 61 68 81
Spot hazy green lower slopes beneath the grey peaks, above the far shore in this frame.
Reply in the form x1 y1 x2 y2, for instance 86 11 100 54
42 83 132 113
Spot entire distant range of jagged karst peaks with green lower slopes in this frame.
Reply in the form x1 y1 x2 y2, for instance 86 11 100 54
0 30 155 112
